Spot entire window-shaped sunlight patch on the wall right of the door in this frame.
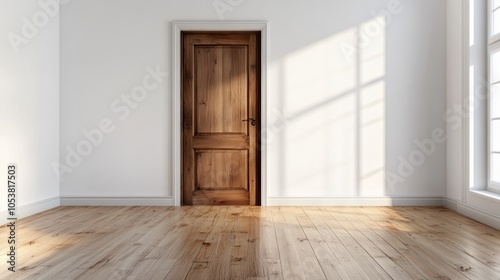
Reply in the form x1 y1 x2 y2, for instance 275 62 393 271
271 17 385 197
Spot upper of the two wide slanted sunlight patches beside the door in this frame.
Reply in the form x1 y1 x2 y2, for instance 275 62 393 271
281 28 356 116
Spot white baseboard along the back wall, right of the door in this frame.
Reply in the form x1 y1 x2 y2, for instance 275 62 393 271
267 196 443 206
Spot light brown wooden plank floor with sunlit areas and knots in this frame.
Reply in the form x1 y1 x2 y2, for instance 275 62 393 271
0 206 500 280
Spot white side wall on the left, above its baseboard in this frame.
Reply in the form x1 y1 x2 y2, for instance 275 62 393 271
0 1 59 217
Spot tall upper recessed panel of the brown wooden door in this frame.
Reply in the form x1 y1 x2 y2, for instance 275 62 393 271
195 46 248 134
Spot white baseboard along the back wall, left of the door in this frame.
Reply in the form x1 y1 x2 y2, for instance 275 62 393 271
61 196 174 206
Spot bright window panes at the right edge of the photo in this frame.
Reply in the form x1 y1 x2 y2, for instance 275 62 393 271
488 0 500 193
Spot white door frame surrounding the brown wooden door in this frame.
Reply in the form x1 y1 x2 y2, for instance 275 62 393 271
171 21 270 206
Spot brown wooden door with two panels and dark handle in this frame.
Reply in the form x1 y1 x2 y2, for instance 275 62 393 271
182 32 260 205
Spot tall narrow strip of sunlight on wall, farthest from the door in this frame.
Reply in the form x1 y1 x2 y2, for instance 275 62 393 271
358 17 386 195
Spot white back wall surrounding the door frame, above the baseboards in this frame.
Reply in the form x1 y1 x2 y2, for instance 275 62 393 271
60 0 446 205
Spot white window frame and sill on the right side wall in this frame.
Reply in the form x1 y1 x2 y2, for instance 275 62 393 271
458 0 500 229
